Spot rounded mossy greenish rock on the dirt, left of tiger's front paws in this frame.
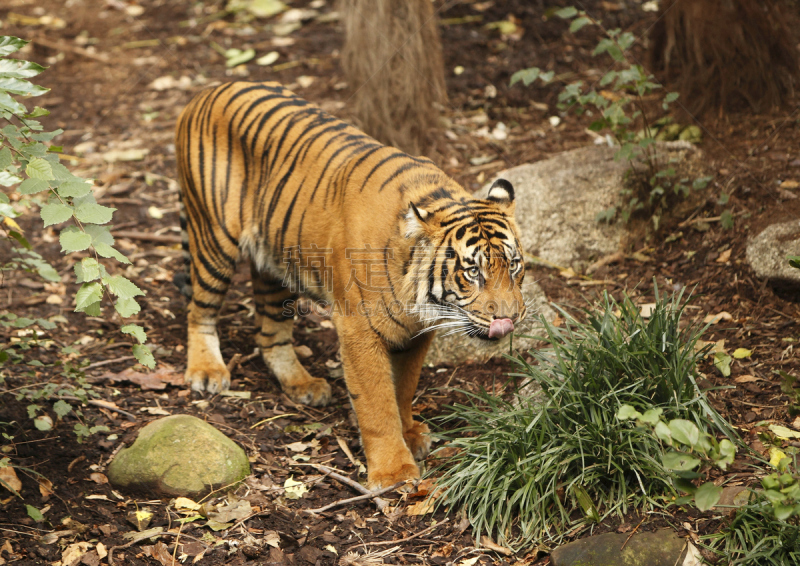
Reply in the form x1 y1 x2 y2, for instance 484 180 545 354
108 415 250 498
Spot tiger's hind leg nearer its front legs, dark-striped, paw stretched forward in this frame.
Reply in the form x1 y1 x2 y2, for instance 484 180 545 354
250 264 331 407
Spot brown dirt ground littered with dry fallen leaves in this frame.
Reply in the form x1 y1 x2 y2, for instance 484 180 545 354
0 0 800 566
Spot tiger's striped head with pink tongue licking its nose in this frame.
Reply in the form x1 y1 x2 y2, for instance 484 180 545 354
406 179 527 340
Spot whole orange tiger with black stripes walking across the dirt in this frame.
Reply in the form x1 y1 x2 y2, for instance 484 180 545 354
175 82 526 488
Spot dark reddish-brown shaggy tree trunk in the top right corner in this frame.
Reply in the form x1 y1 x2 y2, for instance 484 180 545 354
650 0 798 114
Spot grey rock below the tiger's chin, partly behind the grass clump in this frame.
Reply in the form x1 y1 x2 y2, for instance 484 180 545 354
425 276 556 365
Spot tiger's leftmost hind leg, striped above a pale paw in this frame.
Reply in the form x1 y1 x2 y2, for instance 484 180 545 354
184 233 236 393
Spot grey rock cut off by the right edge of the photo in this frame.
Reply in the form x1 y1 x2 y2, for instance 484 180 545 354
747 220 800 284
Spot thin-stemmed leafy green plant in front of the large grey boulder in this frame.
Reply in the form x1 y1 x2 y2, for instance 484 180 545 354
511 6 711 230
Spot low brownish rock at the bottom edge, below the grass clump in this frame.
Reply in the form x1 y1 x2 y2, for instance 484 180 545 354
550 529 687 566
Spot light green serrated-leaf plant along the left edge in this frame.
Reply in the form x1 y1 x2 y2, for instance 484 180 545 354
0 36 155 437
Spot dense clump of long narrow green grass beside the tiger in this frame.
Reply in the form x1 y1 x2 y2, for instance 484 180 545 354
438 289 732 548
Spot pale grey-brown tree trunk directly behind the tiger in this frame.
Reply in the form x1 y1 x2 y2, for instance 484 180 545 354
341 0 446 155
